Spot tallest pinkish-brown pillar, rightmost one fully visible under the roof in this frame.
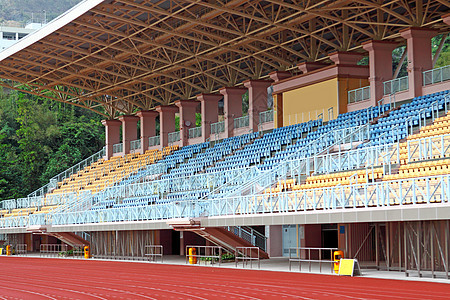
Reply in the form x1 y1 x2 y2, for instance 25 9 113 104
400 27 436 98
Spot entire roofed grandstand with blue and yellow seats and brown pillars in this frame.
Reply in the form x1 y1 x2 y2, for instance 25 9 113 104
0 0 450 279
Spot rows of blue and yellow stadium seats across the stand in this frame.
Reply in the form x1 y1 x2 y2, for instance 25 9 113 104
0 91 450 217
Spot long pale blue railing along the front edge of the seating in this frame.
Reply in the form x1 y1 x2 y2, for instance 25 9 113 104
0 175 450 228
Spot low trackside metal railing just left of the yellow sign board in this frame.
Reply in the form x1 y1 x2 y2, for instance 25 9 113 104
289 247 338 274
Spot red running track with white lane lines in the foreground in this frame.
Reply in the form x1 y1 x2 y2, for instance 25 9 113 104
0 257 450 300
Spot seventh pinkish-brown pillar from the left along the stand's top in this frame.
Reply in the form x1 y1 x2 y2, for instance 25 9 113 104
219 87 247 137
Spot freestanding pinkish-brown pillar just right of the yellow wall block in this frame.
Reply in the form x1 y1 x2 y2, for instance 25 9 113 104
363 41 397 106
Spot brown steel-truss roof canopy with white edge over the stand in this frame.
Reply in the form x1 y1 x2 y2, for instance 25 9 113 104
0 0 450 118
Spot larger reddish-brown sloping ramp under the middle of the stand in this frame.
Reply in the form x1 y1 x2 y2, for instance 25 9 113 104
167 219 269 259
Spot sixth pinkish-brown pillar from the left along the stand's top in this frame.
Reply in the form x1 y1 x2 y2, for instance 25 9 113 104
197 94 223 142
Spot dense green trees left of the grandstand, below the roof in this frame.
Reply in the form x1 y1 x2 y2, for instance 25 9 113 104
0 91 104 199
